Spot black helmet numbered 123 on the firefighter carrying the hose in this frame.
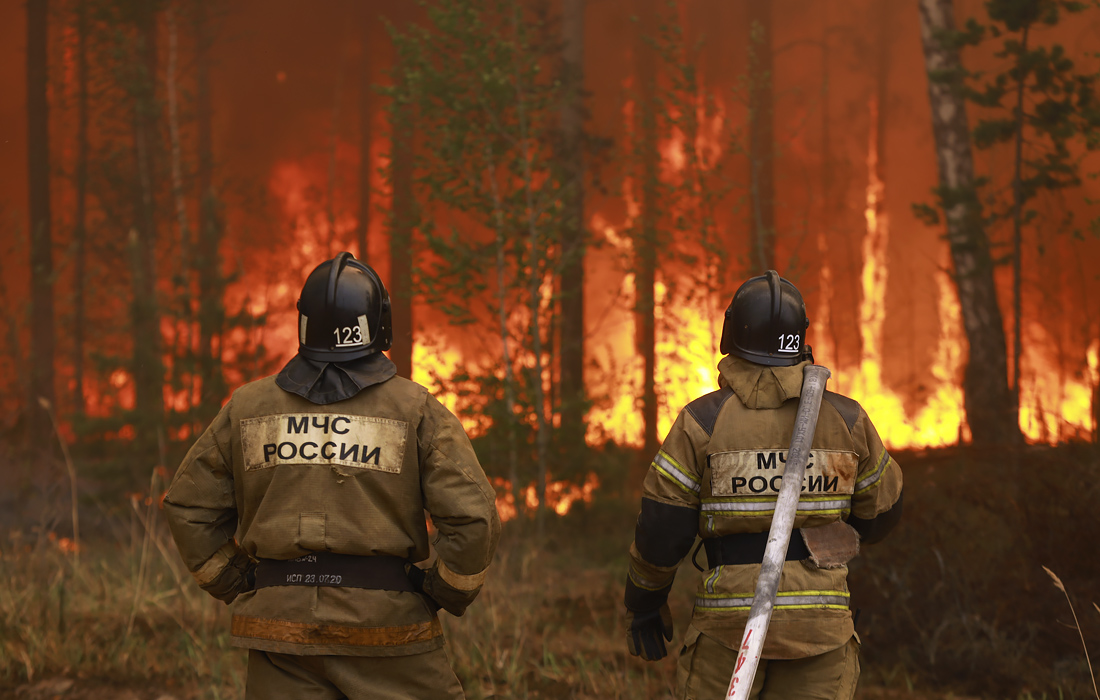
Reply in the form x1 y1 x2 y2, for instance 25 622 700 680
722 270 812 367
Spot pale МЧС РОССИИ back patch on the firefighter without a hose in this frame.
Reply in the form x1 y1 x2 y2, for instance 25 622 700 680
241 413 408 474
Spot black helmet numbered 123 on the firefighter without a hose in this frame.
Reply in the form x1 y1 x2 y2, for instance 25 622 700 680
298 252 394 362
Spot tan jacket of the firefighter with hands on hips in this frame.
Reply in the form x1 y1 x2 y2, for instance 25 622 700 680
164 376 501 656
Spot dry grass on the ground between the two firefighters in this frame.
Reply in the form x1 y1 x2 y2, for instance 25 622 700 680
435 532 686 700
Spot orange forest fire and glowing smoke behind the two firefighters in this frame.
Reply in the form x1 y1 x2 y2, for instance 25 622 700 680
3 3 1100 521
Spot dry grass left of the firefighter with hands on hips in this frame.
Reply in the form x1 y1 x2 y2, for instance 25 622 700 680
0 503 244 699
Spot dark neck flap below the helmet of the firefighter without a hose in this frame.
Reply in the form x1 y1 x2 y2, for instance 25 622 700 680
275 352 397 405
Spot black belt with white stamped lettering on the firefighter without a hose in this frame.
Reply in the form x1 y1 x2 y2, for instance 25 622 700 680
256 551 416 592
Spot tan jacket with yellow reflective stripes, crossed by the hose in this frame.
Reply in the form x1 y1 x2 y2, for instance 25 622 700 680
627 356 902 659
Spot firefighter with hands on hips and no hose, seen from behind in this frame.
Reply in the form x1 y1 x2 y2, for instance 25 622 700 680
164 253 501 700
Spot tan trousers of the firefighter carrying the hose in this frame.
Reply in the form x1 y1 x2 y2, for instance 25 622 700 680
677 628 859 700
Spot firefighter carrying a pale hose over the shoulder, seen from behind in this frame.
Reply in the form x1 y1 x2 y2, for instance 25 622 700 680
626 271 902 700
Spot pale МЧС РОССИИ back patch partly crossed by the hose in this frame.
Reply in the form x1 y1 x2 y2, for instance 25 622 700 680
710 450 859 496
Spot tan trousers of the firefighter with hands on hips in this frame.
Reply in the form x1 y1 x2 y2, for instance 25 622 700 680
244 648 465 700
